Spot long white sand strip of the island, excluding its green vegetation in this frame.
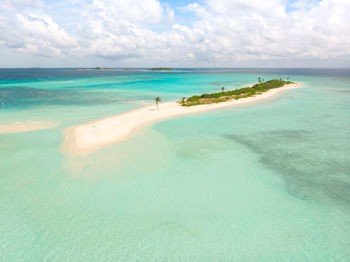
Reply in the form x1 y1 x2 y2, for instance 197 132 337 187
61 83 301 155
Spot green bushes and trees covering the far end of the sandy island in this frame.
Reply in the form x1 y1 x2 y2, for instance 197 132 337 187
179 78 293 106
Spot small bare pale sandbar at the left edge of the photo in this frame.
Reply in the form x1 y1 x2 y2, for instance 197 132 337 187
0 121 57 134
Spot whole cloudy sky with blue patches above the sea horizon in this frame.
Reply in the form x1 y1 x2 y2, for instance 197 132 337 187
0 0 350 67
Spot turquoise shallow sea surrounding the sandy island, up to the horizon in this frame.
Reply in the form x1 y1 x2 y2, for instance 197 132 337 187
0 69 350 262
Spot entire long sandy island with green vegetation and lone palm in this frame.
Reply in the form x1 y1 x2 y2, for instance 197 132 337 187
61 80 301 155
